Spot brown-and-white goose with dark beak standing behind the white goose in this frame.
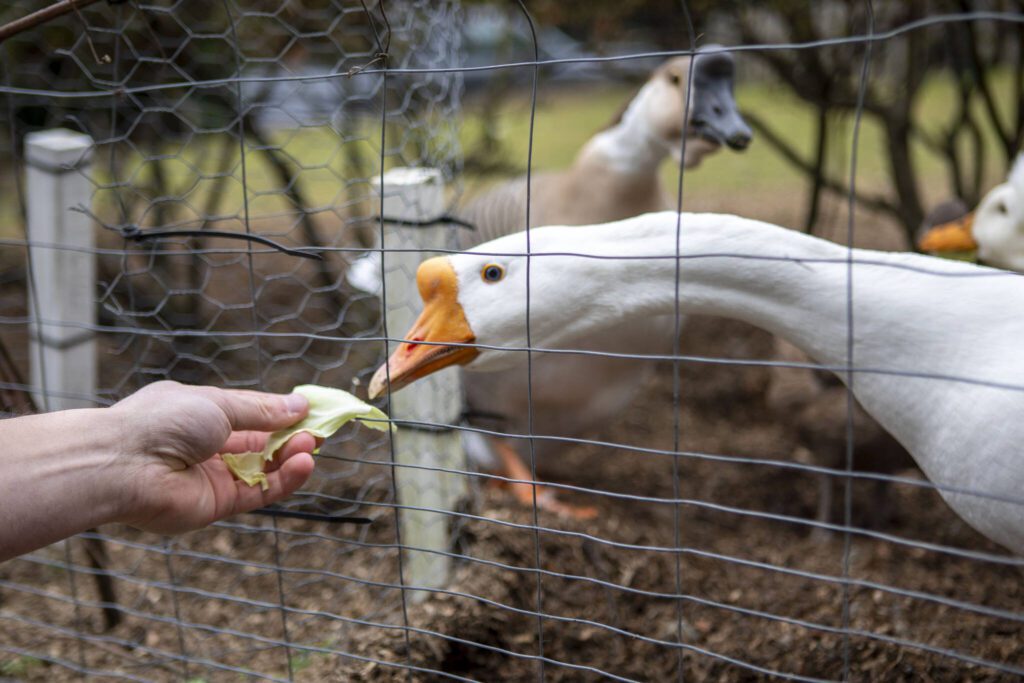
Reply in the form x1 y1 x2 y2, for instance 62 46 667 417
360 45 752 517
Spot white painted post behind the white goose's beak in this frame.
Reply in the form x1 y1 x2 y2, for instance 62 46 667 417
379 168 467 602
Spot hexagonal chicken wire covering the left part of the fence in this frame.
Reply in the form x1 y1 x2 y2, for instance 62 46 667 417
2 0 462 679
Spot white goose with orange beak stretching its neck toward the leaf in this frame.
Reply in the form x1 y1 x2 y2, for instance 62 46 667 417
371 212 1024 554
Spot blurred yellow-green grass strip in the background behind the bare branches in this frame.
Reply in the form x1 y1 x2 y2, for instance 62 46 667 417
0 72 1012 244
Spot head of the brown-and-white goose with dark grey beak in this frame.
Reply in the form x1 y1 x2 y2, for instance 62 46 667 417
638 45 753 168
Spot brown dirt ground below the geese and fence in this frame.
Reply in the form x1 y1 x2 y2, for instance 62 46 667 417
0 318 1024 681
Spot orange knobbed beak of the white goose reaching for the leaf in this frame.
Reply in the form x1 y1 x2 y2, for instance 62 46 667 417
370 257 479 399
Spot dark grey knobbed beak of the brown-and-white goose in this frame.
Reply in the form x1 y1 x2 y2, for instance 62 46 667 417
690 51 754 151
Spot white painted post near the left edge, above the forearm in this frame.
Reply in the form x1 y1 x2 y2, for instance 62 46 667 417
25 128 96 411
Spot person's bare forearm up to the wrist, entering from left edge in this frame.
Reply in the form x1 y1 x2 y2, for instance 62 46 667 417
0 409 126 561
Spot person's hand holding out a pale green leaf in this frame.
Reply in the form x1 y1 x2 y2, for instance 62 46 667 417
108 382 316 533
